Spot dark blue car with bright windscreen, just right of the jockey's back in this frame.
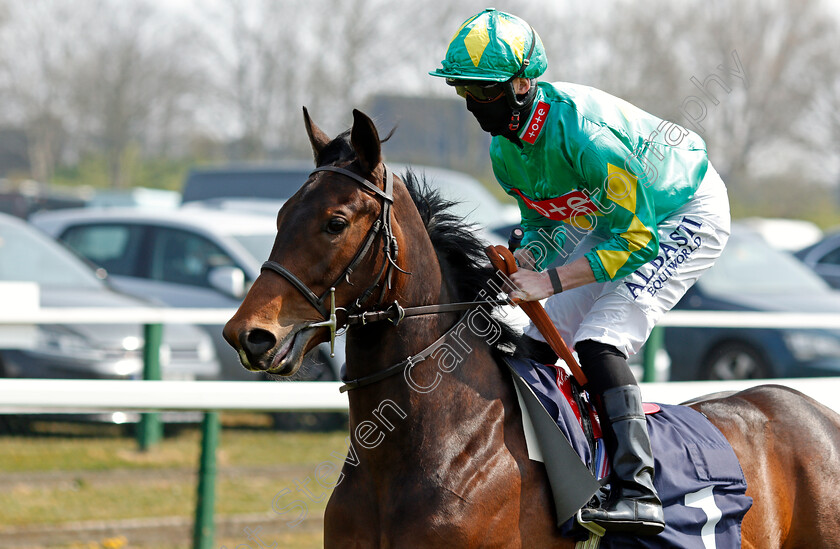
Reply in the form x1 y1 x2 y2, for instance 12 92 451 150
665 224 840 381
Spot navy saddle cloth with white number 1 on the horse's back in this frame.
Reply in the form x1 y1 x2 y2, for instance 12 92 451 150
508 359 752 549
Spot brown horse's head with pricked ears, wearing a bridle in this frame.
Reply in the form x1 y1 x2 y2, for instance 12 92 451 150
223 109 433 376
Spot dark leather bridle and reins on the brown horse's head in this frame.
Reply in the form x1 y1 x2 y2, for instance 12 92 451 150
260 165 512 392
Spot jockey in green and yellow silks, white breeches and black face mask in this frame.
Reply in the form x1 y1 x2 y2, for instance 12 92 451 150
430 8 729 535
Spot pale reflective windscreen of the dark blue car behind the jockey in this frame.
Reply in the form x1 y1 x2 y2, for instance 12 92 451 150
698 228 828 295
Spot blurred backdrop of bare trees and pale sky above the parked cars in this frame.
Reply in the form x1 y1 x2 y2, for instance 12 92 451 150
0 0 840 223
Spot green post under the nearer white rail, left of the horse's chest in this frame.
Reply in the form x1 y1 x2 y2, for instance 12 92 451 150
193 412 221 549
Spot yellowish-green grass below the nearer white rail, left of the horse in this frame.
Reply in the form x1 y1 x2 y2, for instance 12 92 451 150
0 414 347 549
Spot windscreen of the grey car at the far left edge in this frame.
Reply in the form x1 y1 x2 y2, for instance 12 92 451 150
0 220 102 288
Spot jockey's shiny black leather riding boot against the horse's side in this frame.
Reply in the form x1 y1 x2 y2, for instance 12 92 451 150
581 385 665 535
